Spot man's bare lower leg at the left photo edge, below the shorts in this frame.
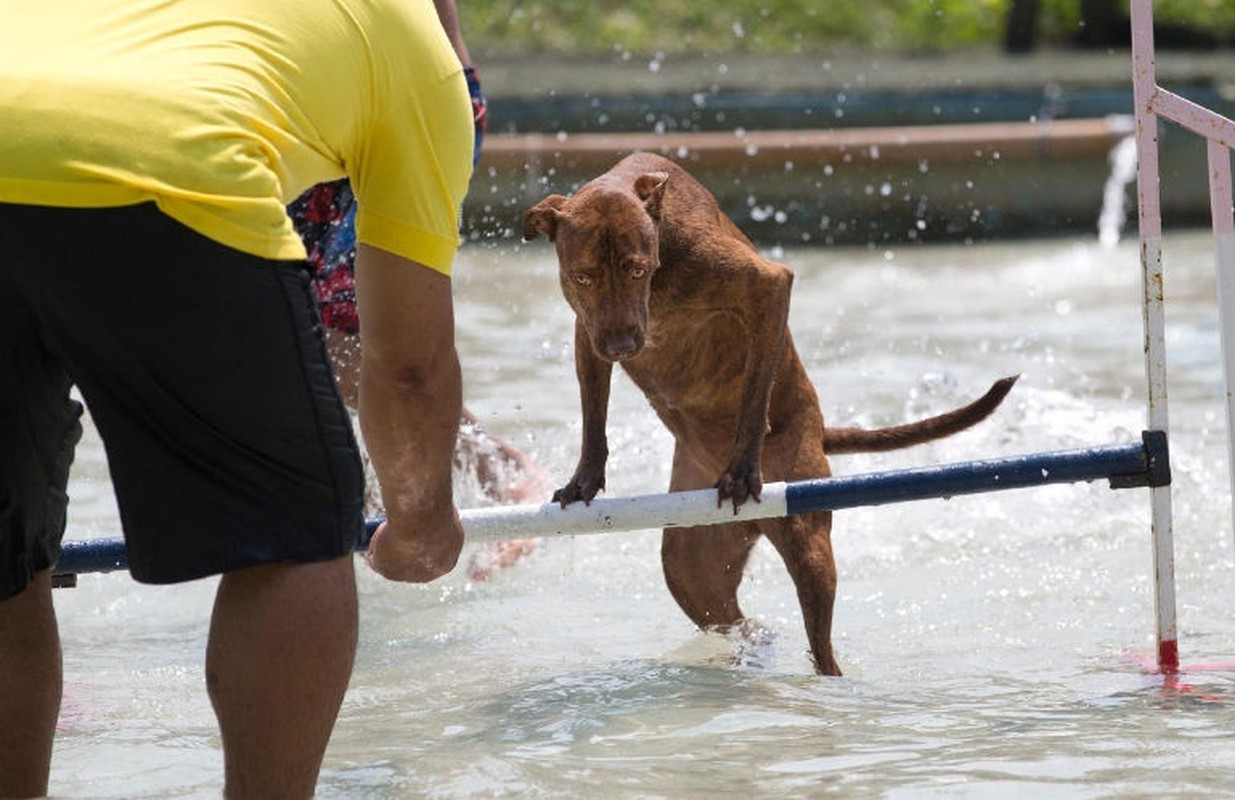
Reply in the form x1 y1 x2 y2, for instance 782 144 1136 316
0 570 62 798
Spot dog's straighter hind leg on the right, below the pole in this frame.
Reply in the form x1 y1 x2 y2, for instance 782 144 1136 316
764 511 841 675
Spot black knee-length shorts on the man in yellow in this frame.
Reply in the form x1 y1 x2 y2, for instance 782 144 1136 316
0 204 363 599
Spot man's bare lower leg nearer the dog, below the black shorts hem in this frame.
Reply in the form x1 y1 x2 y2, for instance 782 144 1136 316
206 556 357 799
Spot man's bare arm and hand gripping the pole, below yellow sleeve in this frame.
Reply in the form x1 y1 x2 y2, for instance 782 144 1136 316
356 244 463 581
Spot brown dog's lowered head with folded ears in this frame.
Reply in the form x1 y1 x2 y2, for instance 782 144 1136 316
524 172 669 362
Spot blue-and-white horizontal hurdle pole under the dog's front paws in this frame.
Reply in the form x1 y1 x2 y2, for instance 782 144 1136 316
56 431 1171 583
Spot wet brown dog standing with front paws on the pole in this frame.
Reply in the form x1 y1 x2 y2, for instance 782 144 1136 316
524 153 1015 675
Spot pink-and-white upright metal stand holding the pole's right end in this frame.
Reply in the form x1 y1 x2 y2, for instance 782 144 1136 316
1130 0 1235 674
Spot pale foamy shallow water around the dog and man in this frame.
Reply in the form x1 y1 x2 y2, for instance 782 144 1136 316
45 228 1235 798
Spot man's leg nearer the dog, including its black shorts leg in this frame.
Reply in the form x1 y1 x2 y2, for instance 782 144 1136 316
7 206 364 798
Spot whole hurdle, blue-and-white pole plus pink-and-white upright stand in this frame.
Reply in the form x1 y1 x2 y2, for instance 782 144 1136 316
56 0 1235 675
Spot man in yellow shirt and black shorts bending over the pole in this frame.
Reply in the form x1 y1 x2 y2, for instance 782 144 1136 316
0 0 472 798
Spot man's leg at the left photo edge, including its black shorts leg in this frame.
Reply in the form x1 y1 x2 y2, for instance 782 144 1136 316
0 205 82 798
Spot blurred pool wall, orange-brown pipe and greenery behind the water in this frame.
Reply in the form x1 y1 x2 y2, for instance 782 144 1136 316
461 0 1235 244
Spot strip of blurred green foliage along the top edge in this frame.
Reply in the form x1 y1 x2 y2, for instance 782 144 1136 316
459 0 1235 56
